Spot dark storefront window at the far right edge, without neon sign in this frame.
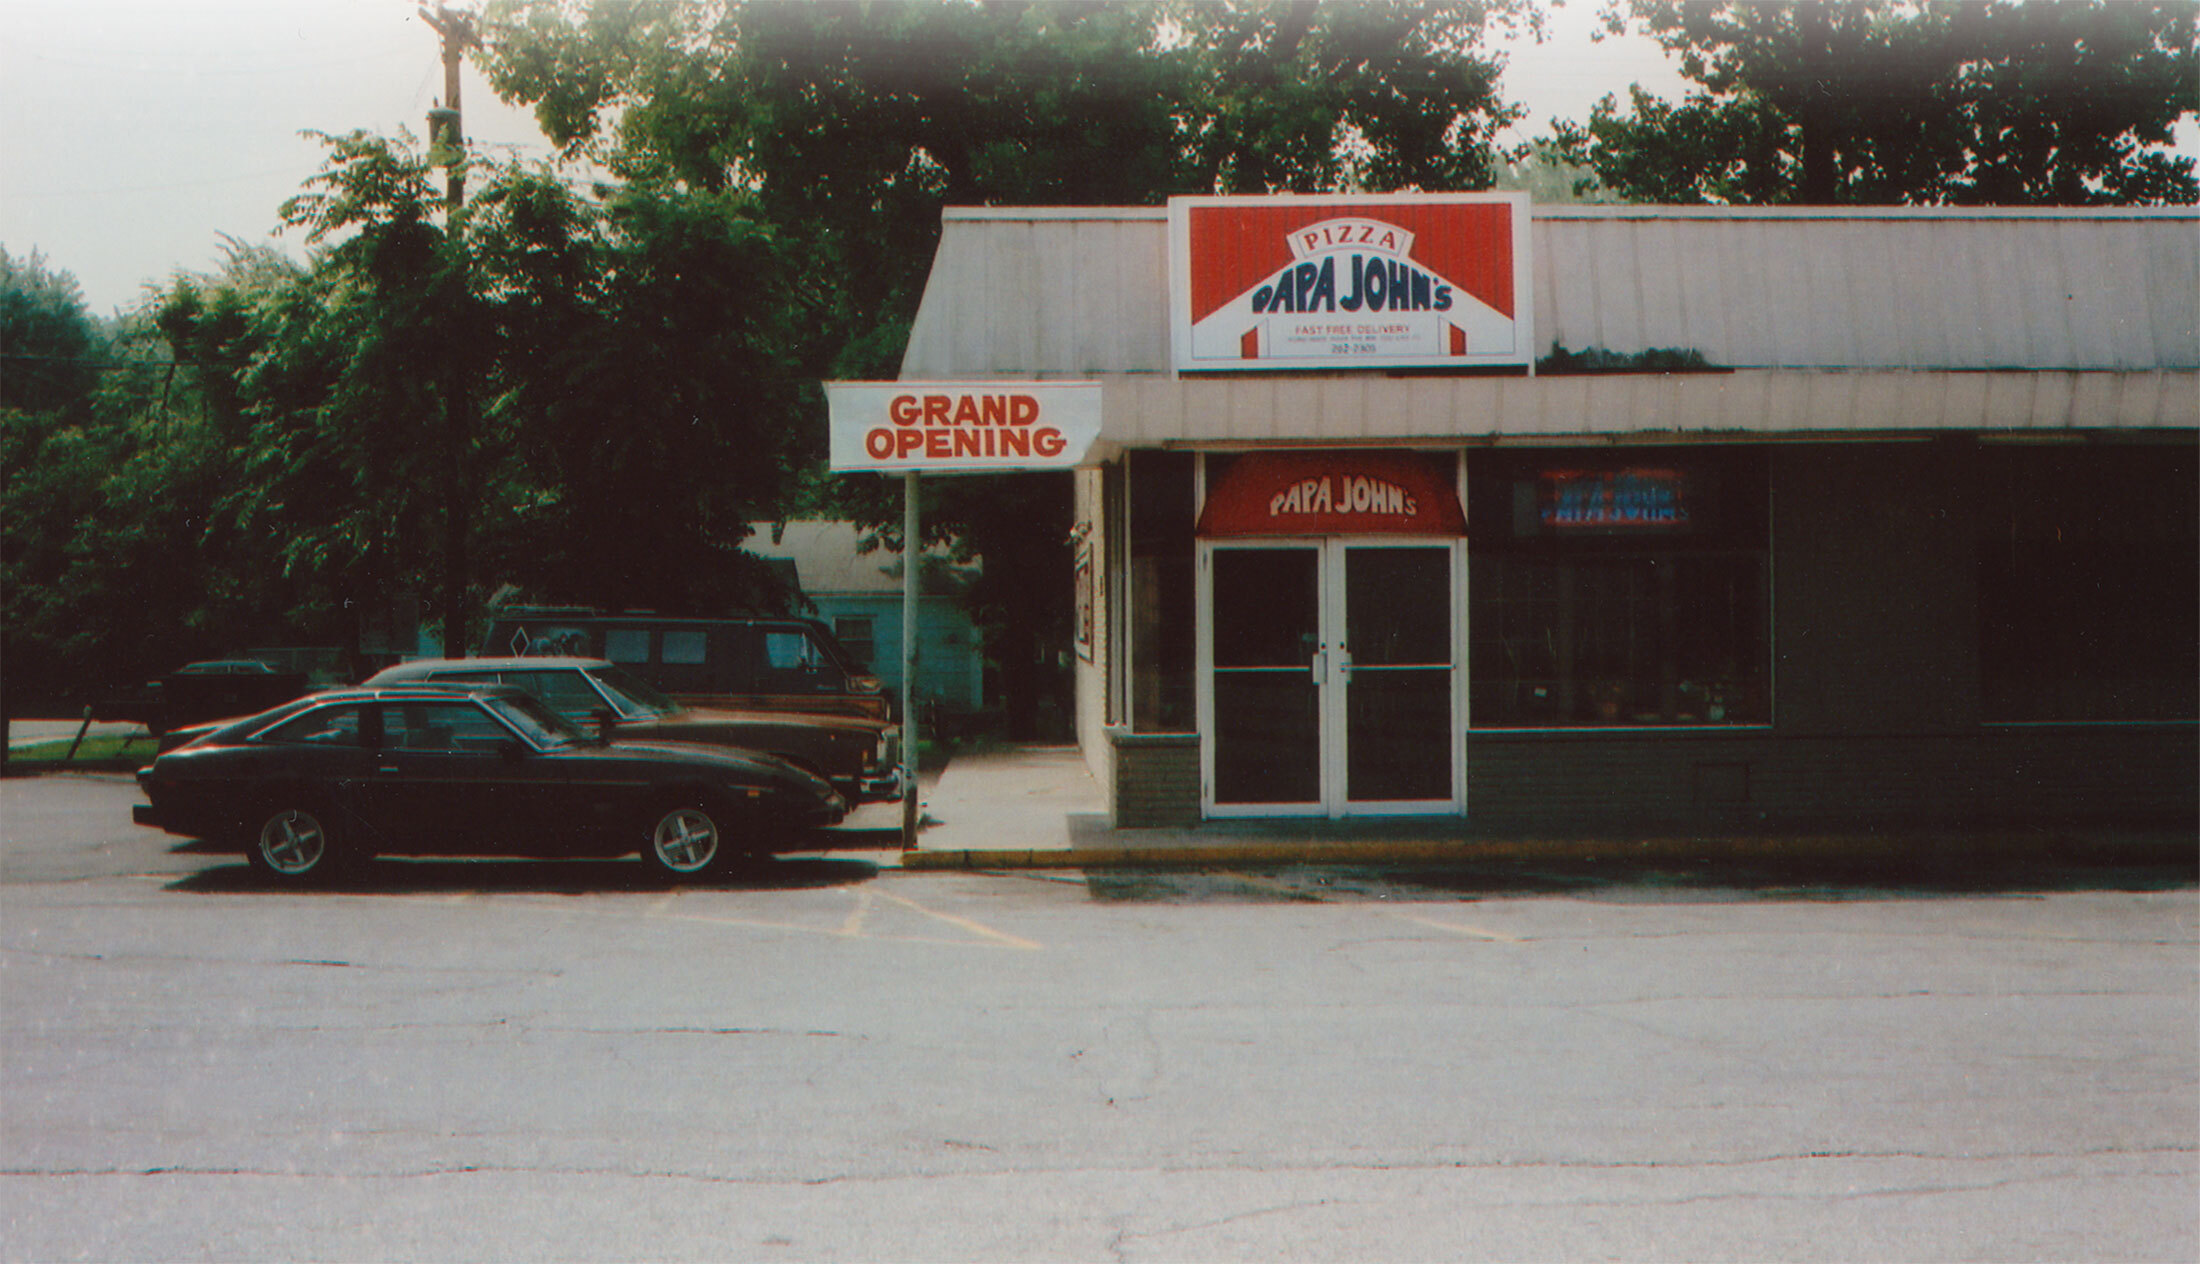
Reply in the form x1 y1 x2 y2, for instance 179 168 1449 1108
1978 444 2200 721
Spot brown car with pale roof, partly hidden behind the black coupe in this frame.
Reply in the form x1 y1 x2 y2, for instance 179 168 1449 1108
365 657 904 802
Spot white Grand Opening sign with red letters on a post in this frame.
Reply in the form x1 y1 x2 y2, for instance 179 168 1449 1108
825 380 1100 475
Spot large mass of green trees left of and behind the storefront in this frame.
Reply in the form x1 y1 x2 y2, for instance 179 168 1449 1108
0 0 1536 729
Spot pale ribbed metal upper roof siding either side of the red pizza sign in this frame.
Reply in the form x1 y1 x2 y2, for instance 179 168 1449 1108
902 207 2200 378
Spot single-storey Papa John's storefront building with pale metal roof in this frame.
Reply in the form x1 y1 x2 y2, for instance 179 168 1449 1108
902 196 2200 835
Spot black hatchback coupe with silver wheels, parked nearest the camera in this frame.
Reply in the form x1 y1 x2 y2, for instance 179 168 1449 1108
136 684 847 882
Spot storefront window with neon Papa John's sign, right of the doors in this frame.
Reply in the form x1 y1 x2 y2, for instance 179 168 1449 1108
1467 448 1771 728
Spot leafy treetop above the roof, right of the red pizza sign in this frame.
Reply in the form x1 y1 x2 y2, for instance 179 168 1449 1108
1558 0 2200 204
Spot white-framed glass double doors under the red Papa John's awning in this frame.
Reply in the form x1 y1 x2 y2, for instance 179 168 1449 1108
1199 539 1461 816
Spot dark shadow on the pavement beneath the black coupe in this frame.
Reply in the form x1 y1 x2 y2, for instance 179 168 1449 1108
167 842 878 895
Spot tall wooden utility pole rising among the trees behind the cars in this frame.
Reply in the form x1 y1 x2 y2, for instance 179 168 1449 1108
420 0 480 657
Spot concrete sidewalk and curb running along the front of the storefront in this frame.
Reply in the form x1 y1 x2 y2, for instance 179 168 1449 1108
884 747 2200 877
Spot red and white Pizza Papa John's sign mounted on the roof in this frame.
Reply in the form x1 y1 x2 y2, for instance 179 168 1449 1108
1168 193 1536 374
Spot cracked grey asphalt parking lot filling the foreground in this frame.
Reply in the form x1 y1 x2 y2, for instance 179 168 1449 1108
0 776 2200 1260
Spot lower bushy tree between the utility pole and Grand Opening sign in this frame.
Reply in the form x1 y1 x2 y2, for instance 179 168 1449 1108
471 174 823 613
